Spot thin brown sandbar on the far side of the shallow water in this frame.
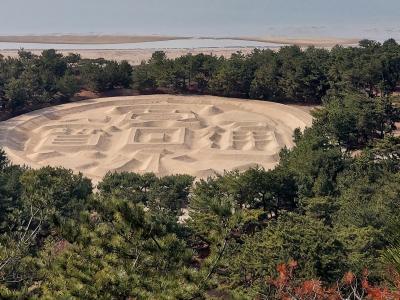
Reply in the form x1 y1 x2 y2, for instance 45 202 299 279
0 35 360 47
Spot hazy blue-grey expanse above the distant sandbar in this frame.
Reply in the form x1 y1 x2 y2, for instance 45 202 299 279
0 0 400 36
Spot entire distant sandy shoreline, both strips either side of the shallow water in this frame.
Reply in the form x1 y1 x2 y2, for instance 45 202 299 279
0 35 358 65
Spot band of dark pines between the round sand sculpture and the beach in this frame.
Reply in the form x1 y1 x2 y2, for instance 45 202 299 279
0 40 400 115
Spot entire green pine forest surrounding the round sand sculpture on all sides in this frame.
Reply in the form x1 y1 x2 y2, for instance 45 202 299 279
0 41 400 299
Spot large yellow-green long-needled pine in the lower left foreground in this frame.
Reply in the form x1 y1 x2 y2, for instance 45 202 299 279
35 198 202 299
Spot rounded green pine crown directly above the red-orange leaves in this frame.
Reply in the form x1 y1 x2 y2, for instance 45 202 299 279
222 213 346 292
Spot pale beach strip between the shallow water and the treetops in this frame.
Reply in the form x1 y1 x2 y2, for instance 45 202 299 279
0 47 266 65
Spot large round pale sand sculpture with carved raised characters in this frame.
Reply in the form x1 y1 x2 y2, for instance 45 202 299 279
0 95 312 181
